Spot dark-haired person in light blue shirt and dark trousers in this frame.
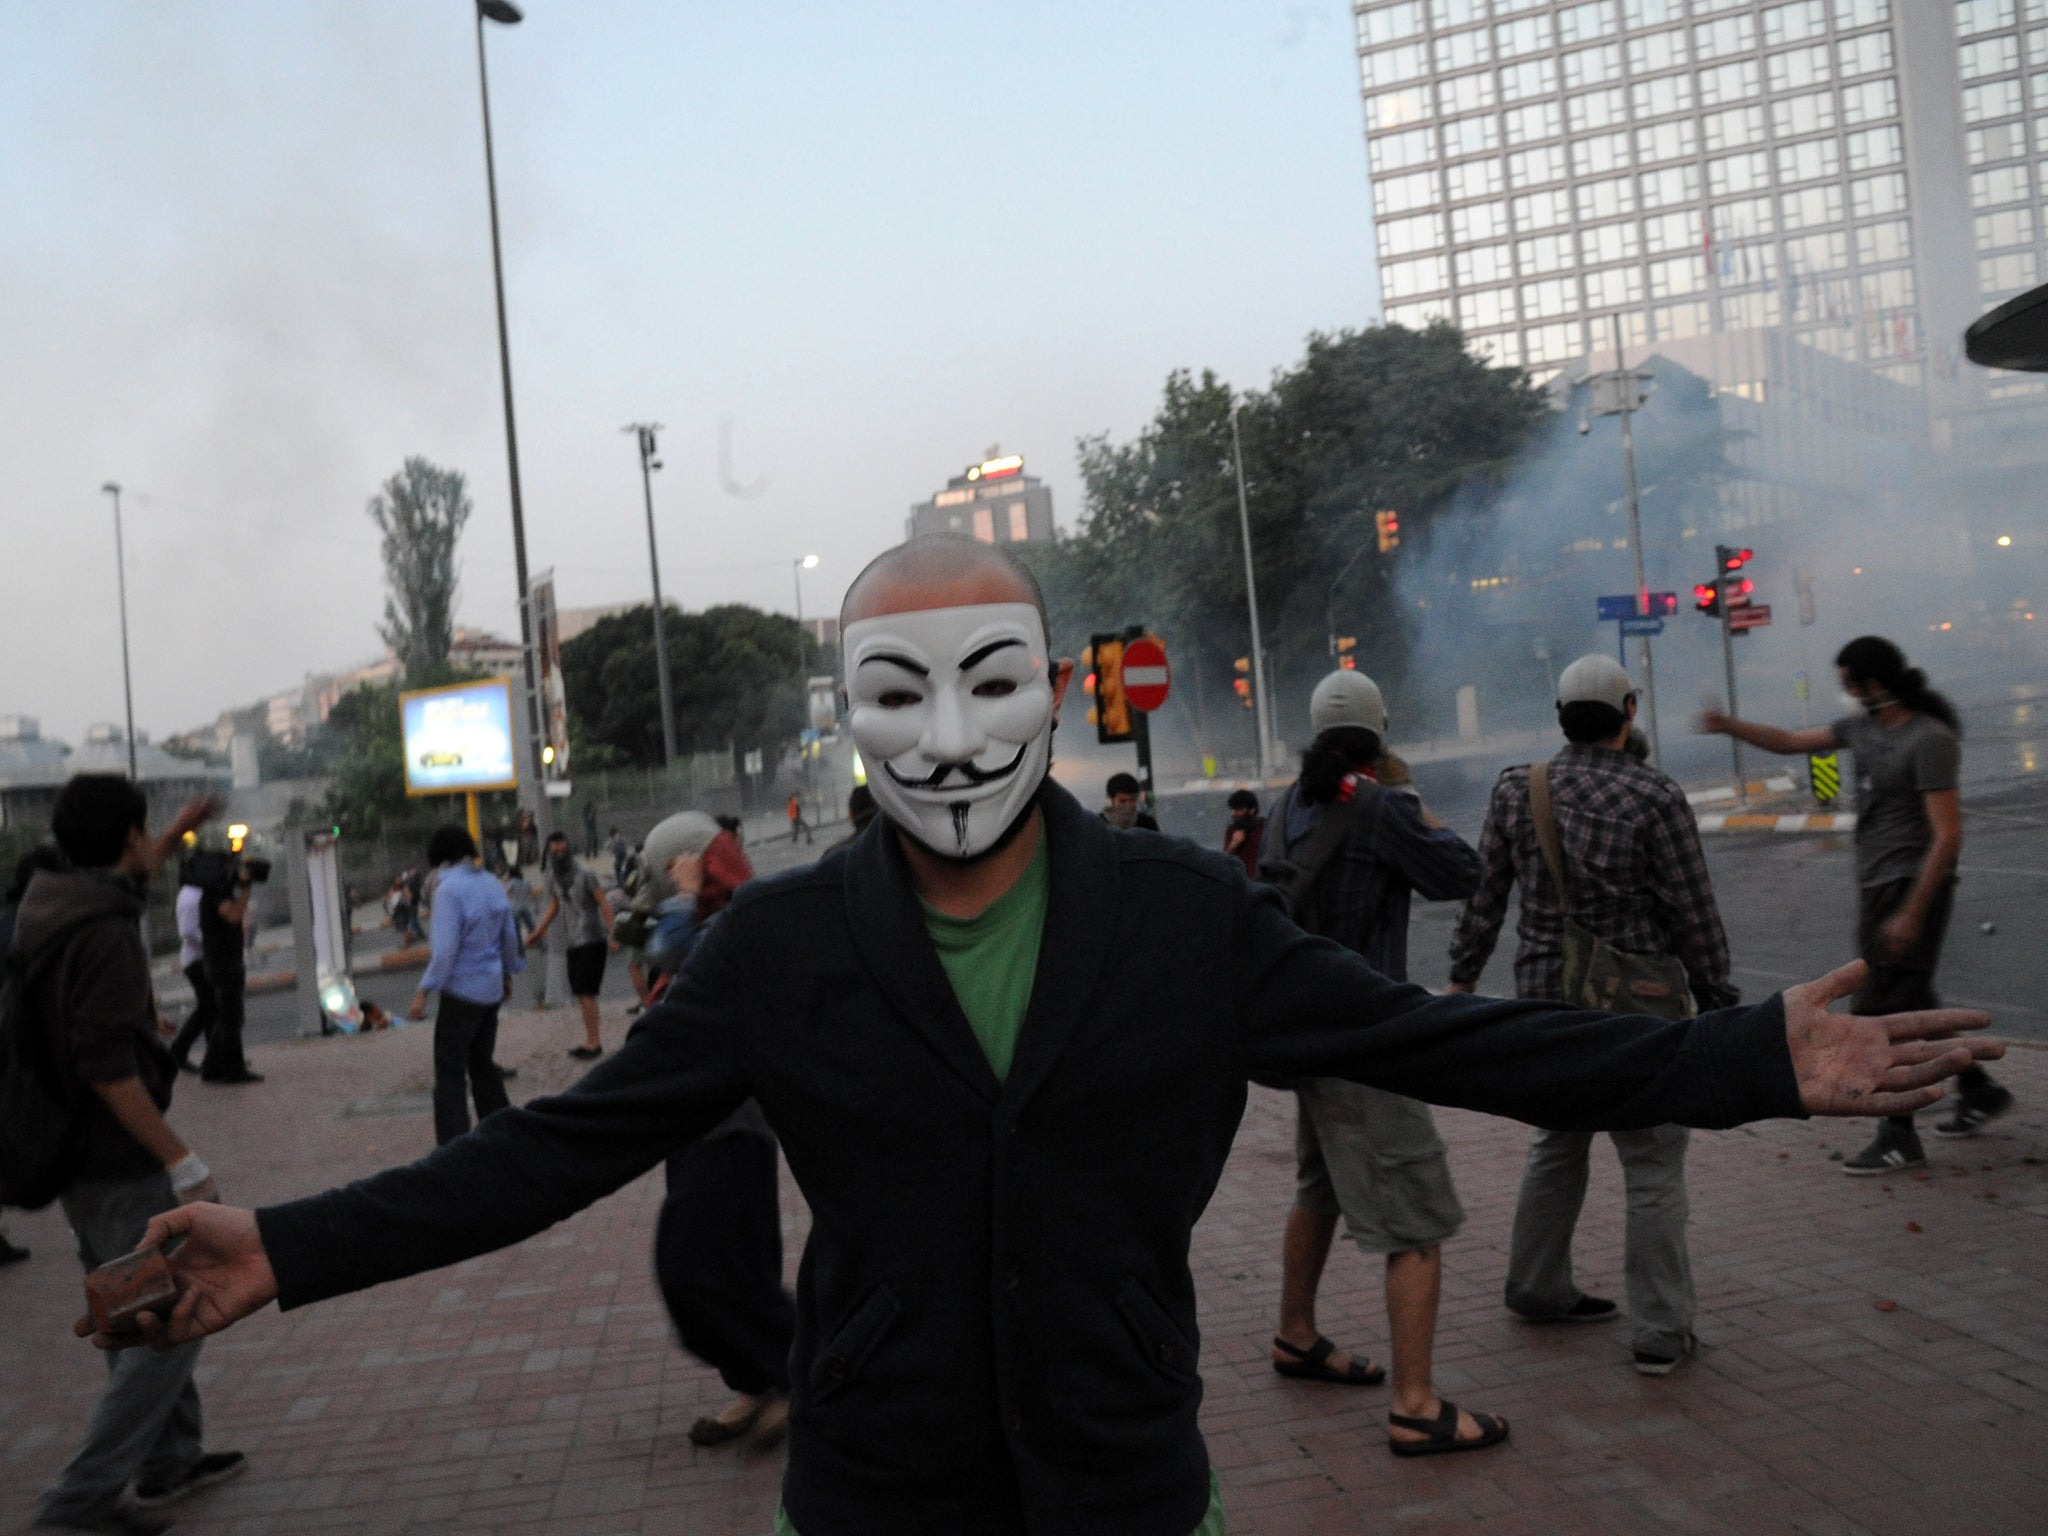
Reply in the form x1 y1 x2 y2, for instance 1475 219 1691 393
410 827 526 1147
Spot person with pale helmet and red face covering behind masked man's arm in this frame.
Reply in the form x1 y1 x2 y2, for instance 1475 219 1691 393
639 811 797 1446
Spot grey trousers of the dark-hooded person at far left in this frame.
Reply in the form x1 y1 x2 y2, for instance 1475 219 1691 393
35 1174 205 1526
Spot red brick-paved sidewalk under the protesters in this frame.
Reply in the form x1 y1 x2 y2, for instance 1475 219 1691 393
0 1010 2048 1536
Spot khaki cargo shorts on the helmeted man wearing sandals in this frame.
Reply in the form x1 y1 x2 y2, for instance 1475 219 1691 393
1294 1077 1464 1253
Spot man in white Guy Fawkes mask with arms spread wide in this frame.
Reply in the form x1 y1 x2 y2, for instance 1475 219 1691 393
102 539 2001 1536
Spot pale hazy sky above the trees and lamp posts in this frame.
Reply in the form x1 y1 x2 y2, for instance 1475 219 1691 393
0 0 1376 739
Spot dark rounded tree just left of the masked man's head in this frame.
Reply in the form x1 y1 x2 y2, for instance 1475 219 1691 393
561 604 836 768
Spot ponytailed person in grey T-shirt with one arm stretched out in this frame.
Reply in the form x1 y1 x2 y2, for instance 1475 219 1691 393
1700 635 2013 1178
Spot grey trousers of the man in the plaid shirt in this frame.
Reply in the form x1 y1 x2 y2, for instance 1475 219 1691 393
1507 1124 1700 1358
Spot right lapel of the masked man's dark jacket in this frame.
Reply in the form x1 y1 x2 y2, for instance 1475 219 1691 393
1004 780 1114 1114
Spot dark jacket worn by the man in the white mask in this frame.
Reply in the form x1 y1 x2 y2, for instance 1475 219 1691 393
258 786 1800 1536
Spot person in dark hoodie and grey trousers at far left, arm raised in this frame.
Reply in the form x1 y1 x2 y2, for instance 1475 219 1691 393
14 774 246 1532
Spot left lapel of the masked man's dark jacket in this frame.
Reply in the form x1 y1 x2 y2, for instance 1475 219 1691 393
846 821 1001 1104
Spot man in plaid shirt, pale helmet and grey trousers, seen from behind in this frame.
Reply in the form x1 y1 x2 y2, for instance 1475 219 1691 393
1450 655 1739 1376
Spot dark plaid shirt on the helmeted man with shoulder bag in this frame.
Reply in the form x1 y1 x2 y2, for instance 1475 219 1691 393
1450 745 1739 1012
